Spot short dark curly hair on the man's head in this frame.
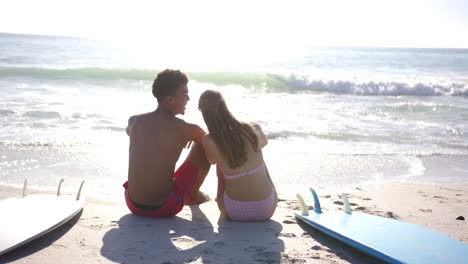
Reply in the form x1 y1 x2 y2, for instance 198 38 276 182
153 69 188 103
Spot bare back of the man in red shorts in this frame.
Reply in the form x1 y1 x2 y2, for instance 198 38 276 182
127 111 190 206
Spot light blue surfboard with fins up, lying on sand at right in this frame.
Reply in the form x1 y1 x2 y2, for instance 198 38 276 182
295 189 468 264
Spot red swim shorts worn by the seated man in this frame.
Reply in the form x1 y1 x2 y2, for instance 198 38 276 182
123 160 198 217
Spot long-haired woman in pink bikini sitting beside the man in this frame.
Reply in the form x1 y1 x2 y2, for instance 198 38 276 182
198 90 278 221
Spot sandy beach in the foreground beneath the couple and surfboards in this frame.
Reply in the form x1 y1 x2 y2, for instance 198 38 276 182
0 182 468 264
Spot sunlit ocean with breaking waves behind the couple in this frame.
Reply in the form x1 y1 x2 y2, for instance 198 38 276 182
0 34 468 199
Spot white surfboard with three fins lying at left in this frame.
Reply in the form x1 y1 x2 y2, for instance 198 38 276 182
0 180 85 256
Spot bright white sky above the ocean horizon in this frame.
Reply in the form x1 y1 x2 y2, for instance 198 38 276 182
0 0 468 48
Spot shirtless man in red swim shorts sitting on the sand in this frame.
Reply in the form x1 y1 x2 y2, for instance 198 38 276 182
124 69 210 217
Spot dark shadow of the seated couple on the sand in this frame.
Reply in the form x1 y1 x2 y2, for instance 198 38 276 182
101 206 284 264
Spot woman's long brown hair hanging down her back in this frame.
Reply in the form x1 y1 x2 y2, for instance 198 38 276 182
198 90 259 168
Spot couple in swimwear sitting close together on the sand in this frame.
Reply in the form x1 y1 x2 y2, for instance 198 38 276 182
124 69 277 221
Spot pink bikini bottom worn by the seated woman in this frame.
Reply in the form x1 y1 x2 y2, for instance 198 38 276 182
224 190 276 221
